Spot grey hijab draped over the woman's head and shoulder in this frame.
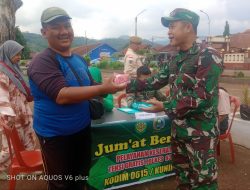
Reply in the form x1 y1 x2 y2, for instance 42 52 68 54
0 40 30 100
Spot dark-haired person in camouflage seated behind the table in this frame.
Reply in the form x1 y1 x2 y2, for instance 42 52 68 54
126 65 166 108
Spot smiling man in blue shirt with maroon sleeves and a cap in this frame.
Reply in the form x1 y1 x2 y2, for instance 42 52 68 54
28 7 125 190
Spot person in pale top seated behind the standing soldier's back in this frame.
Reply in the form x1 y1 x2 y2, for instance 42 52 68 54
218 87 231 135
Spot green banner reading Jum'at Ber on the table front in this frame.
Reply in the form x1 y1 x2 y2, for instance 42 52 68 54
88 116 173 189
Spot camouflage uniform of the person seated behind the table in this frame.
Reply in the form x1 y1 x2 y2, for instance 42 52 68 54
126 90 166 107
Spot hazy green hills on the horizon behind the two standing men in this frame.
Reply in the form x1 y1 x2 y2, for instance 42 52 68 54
22 32 168 52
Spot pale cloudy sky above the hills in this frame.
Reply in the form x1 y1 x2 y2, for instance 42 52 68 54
16 0 250 40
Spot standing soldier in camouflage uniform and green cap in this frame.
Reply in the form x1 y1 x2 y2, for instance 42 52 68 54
127 9 223 190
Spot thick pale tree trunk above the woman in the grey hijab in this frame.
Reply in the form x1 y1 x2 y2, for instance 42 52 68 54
0 0 23 44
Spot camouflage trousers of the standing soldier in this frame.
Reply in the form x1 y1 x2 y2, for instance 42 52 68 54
172 137 218 190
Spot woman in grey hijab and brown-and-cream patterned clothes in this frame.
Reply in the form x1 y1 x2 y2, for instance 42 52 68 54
0 40 35 179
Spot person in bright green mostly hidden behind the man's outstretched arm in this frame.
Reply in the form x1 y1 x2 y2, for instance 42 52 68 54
88 64 114 112
